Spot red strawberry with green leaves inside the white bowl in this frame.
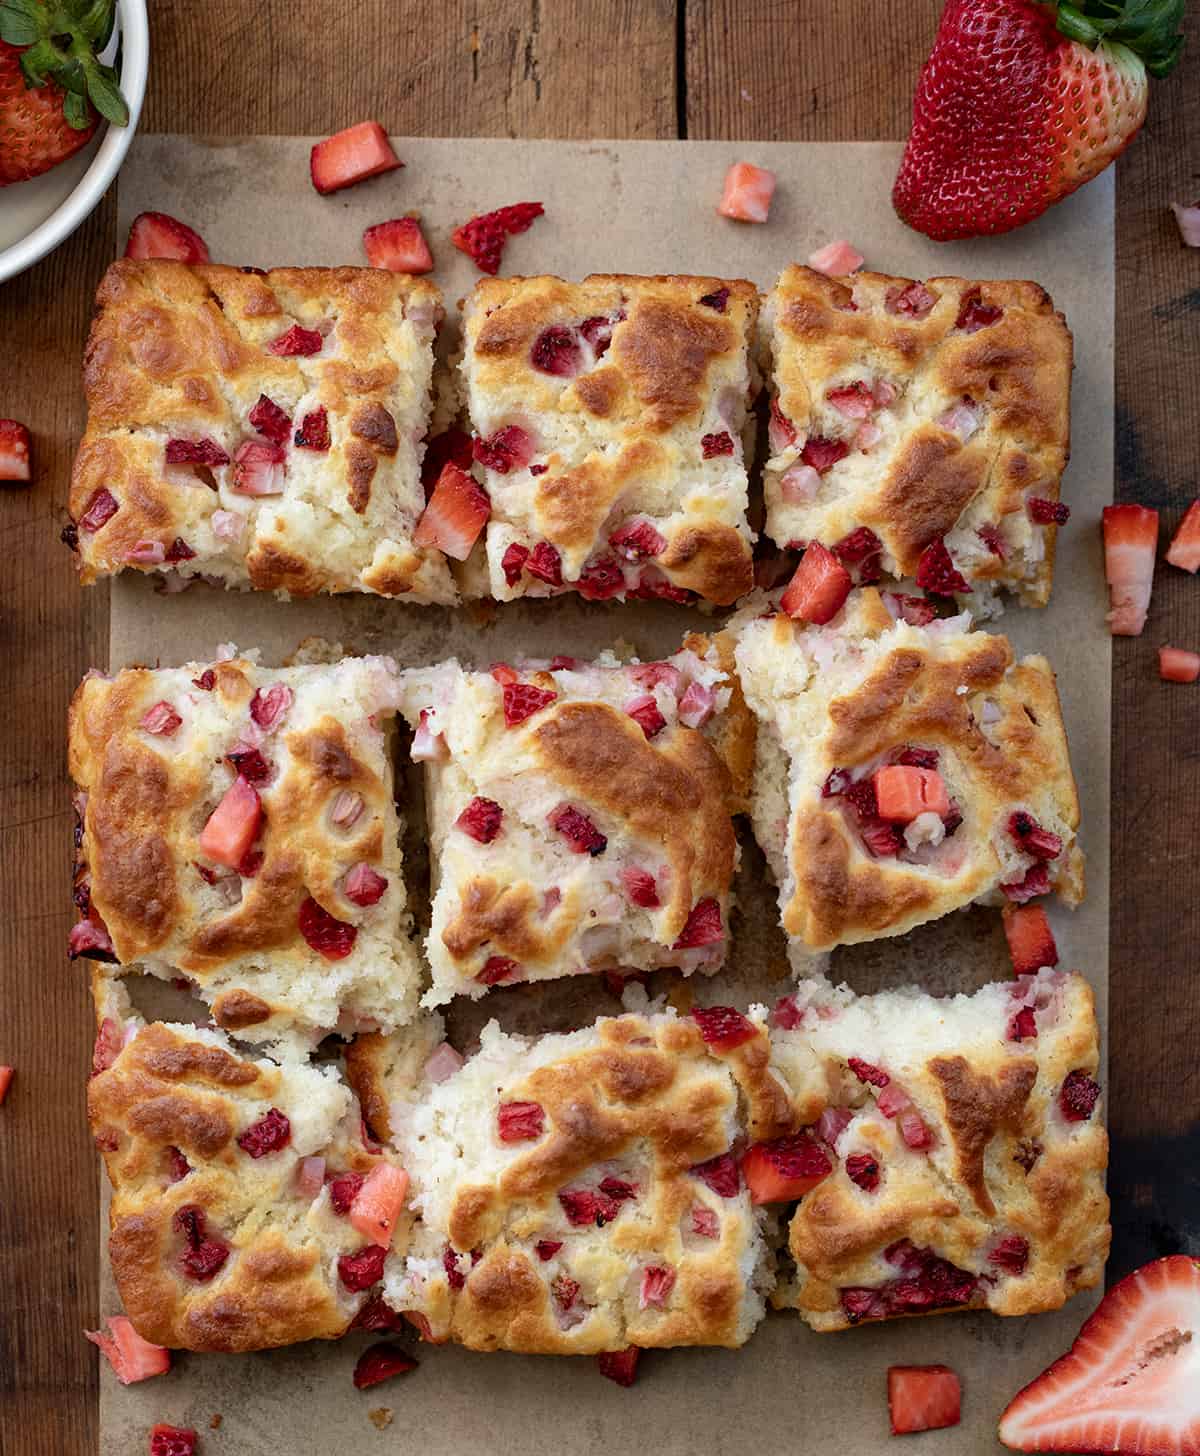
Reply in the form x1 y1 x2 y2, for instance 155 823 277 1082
0 0 130 186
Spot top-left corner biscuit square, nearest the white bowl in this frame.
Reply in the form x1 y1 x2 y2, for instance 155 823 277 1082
68 258 456 603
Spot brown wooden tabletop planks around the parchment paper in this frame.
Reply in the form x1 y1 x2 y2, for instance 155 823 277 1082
0 0 1200 1456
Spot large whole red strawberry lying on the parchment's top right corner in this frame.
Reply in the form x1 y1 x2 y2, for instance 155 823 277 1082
891 0 1185 240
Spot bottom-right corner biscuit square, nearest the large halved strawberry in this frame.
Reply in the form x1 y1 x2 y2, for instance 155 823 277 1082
772 970 1110 1331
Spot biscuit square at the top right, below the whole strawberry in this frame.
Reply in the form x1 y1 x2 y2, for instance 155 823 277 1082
763 265 1072 616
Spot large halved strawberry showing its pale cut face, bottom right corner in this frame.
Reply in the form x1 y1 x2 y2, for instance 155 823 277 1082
1000 1254 1200 1456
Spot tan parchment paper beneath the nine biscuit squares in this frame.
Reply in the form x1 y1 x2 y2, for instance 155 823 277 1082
100 135 1113 1456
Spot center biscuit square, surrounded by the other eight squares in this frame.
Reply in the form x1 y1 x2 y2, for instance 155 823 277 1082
403 649 738 1006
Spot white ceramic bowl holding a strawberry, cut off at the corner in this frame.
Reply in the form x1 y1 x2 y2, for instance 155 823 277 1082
0 0 150 282
